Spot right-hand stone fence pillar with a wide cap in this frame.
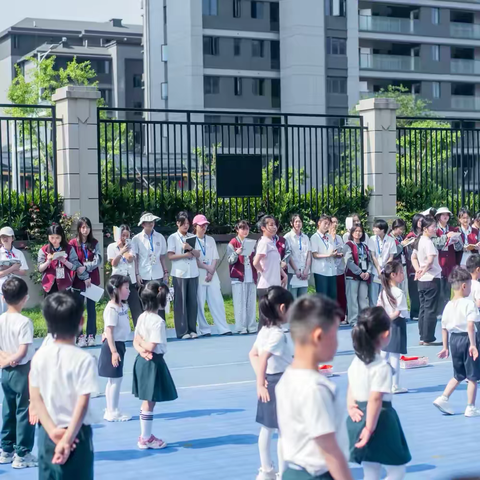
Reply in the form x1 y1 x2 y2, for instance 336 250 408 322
357 98 399 224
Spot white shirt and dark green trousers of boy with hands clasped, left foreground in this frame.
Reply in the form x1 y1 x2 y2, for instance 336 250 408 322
29 342 98 480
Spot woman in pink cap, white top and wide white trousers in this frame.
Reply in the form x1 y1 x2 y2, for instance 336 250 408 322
193 215 232 336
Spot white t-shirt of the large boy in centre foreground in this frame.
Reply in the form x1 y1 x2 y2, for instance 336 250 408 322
276 367 349 477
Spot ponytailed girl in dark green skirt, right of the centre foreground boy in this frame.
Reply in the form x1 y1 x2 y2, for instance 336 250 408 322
347 307 412 480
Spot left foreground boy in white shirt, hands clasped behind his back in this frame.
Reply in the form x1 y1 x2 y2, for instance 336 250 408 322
30 292 98 480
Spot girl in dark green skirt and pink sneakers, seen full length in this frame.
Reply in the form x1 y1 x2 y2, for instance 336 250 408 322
132 280 178 450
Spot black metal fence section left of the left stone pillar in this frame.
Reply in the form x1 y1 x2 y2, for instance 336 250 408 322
0 104 58 227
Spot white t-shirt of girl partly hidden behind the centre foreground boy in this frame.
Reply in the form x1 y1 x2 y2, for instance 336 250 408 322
254 326 293 374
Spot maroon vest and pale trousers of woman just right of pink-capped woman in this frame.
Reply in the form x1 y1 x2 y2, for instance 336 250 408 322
227 236 257 333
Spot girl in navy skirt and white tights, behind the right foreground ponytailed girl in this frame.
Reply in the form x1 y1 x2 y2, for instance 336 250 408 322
378 260 410 394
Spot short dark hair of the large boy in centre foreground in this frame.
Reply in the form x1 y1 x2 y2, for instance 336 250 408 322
288 293 344 344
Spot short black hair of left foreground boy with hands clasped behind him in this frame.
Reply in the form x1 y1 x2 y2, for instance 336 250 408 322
42 292 85 338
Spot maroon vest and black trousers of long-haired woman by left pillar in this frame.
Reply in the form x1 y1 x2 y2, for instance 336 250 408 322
69 238 102 337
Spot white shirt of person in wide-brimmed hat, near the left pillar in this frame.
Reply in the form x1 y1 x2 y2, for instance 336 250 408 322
132 231 167 281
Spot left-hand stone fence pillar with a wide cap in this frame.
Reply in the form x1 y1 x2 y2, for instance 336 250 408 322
52 86 103 278
